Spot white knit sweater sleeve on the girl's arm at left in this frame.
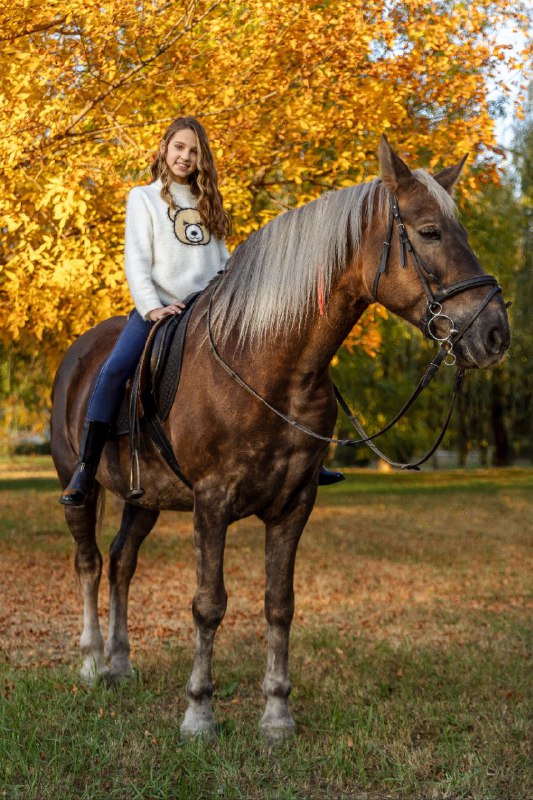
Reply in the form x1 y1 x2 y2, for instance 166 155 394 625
124 188 163 319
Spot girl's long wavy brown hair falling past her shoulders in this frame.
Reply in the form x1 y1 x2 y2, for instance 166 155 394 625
150 117 231 239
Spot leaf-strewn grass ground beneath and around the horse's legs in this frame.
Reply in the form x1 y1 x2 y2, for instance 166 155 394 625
0 460 533 800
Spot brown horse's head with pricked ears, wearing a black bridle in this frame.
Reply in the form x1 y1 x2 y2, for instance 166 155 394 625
370 137 510 368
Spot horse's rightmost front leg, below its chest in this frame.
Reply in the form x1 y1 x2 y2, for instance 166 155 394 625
260 486 316 741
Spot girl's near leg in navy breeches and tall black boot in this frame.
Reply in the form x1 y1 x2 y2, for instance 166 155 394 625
59 310 151 506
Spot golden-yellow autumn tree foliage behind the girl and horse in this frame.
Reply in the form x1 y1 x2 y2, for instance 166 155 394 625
0 0 526 360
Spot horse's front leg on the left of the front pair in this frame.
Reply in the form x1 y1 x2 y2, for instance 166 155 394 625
181 492 227 738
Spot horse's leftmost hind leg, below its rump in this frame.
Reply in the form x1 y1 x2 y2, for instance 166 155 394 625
65 486 108 684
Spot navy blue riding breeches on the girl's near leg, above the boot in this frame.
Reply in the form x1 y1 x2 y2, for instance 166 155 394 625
87 309 153 424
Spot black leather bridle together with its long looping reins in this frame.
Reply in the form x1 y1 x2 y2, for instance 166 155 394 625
207 195 501 470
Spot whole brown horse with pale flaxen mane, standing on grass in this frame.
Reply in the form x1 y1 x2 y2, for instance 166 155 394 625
52 138 509 738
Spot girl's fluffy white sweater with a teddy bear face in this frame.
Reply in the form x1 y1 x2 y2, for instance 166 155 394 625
124 180 229 319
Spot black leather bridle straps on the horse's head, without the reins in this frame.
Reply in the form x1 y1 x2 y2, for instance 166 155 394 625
372 195 501 366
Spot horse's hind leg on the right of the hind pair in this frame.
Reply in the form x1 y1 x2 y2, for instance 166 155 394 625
106 503 159 679
